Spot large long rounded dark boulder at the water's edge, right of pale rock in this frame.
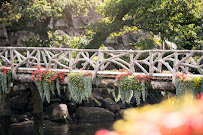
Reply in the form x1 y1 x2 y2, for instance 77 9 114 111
75 107 114 122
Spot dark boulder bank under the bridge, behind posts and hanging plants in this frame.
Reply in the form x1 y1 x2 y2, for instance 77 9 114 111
5 79 170 127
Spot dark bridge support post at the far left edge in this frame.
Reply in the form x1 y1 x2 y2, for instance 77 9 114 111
0 93 11 135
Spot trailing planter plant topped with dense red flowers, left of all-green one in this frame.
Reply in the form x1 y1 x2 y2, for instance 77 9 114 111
32 70 65 103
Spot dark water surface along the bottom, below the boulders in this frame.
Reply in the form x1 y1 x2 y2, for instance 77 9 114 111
12 122 113 135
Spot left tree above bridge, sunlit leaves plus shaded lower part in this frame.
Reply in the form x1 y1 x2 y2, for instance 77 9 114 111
0 0 95 39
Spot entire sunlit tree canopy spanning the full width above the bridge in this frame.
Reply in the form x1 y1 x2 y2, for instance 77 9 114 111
0 0 203 49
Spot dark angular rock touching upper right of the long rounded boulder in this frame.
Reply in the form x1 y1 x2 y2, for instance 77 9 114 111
102 98 120 112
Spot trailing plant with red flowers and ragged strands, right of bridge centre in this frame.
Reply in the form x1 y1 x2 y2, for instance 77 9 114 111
113 73 151 105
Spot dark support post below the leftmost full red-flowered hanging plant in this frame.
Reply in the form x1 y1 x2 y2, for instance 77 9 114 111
32 86 44 135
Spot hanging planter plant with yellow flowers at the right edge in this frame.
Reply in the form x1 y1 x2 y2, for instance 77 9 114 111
175 72 203 97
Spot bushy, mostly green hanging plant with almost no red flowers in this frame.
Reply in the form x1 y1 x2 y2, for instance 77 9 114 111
68 72 92 103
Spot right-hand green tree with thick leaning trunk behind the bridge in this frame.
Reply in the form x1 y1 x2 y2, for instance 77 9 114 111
87 0 203 49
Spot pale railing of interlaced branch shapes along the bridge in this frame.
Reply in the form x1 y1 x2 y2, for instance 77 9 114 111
0 47 203 81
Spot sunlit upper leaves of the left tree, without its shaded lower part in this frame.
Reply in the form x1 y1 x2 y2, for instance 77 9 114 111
0 0 95 25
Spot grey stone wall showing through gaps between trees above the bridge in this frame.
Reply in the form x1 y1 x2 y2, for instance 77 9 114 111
0 9 152 50
